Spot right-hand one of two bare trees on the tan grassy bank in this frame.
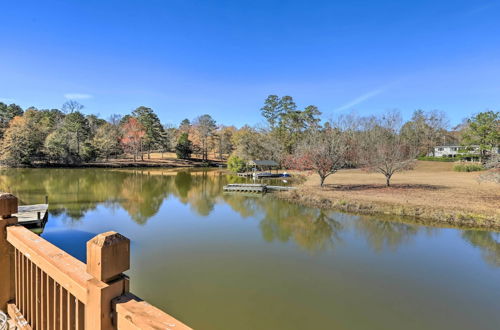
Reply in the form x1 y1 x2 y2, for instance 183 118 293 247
358 112 416 187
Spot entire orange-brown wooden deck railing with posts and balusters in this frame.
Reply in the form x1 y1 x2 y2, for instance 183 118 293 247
0 194 190 330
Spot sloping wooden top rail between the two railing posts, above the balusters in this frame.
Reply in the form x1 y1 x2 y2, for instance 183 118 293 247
7 226 92 303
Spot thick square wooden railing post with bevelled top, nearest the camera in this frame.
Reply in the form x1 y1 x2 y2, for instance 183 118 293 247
85 232 130 330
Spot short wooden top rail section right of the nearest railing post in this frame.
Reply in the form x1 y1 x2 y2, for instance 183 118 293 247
113 293 191 330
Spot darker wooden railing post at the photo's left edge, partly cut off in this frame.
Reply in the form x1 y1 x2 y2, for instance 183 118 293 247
0 193 17 312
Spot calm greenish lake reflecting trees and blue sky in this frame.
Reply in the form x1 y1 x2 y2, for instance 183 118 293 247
0 169 500 330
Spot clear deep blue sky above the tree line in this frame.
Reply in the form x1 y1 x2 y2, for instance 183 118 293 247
0 0 500 126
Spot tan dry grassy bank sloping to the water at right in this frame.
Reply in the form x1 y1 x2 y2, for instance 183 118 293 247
279 162 500 230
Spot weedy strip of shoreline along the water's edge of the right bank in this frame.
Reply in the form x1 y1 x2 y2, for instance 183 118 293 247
273 186 500 231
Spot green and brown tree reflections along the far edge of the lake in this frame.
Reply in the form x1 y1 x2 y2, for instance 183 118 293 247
0 169 500 267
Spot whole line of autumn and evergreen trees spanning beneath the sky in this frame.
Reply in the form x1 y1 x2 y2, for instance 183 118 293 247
0 95 500 185
